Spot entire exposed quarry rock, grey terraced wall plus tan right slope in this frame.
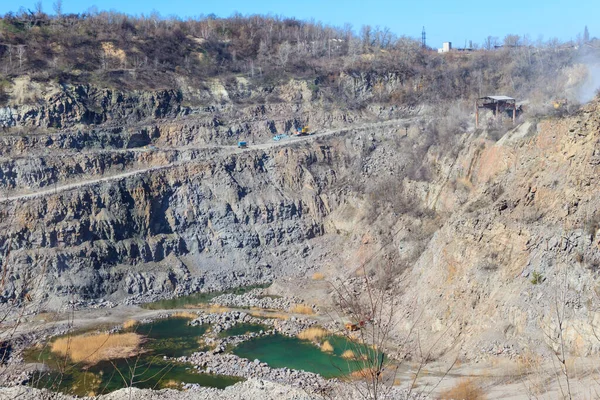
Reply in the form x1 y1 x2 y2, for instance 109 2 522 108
5 75 600 366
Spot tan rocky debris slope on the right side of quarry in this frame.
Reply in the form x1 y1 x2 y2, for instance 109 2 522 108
396 101 600 359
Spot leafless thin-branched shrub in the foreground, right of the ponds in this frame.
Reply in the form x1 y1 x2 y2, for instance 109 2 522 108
331 253 457 400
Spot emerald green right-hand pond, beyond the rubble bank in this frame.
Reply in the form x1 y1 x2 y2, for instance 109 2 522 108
233 335 376 378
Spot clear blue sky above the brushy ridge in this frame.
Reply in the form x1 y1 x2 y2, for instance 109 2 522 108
0 0 600 47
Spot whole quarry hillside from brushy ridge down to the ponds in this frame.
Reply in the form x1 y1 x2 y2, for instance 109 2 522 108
0 7 600 398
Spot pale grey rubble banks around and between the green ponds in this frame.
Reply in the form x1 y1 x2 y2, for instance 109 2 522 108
2 288 338 396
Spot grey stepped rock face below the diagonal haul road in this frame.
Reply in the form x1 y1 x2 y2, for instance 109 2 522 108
0 121 436 304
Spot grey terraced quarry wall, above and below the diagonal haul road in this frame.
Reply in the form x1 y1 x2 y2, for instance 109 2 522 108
0 75 432 307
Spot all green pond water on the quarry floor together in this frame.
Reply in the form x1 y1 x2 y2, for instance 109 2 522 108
25 285 375 396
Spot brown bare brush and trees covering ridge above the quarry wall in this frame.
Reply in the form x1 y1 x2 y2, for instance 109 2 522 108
0 7 593 107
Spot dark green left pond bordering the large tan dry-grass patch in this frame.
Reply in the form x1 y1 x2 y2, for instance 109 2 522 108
27 318 241 396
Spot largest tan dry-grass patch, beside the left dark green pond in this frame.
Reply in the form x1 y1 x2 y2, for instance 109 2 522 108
50 333 142 364
